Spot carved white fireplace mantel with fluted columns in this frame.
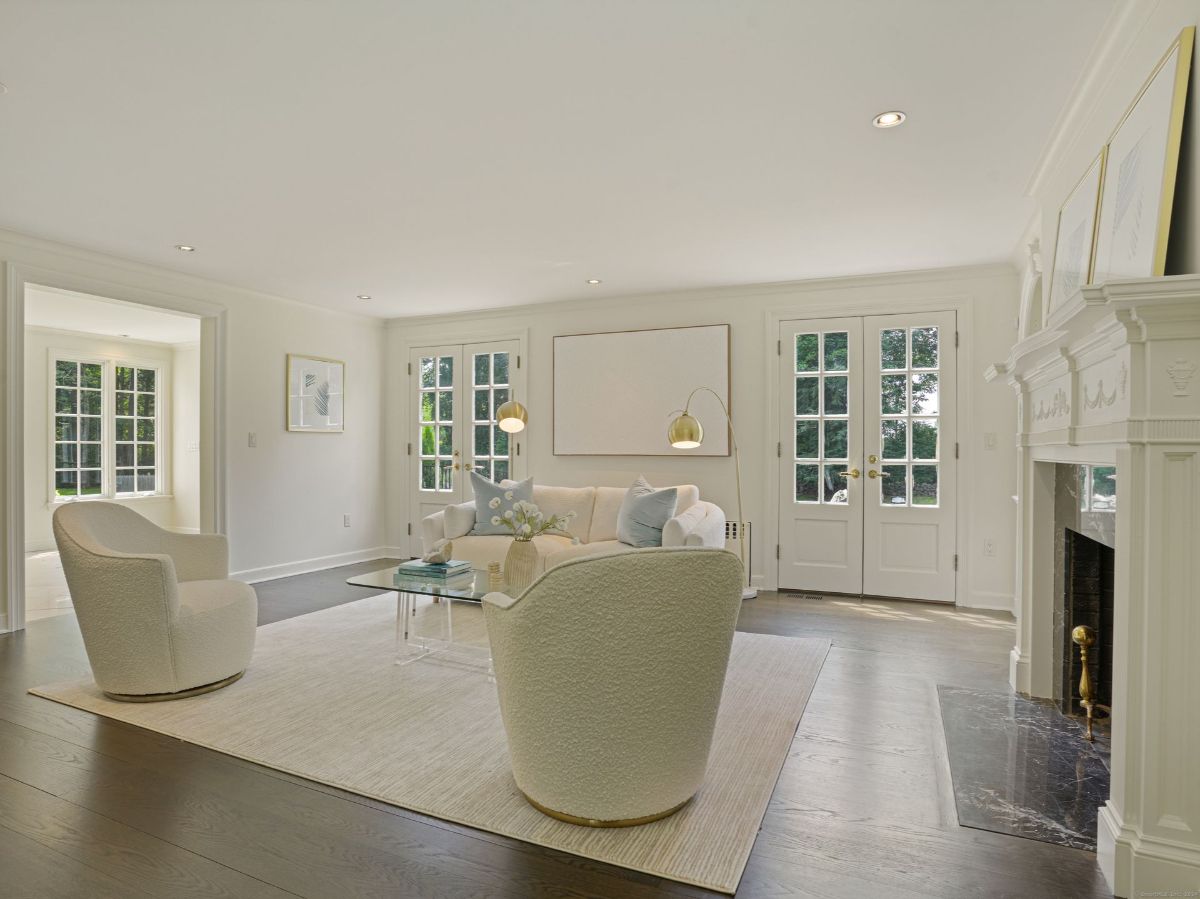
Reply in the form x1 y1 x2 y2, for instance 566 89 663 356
986 275 1200 897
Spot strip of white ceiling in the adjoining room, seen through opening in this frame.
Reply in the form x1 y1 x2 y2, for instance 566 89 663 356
25 284 200 344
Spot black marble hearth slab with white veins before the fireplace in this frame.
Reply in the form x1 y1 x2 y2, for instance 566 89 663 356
937 687 1109 852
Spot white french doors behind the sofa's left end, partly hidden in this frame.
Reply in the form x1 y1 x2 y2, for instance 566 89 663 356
408 341 524 552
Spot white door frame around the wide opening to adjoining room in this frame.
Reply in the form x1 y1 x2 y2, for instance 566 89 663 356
0 260 228 631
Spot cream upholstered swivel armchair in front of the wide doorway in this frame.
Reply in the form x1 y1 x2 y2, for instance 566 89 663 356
54 501 258 702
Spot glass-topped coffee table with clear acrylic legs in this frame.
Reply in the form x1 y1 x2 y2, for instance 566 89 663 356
346 565 504 672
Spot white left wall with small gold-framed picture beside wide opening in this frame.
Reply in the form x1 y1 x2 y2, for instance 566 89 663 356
0 232 385 628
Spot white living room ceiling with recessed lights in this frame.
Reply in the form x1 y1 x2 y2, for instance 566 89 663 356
0 0 1112 316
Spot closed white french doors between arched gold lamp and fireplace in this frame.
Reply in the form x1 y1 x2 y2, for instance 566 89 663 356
779 312 958 603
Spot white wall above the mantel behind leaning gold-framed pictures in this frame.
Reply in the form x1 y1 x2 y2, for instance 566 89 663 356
1027 0 1200 288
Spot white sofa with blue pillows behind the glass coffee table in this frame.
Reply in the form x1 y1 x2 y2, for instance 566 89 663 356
421 481 725 574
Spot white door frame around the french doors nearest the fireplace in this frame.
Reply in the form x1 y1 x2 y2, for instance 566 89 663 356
760 296 974 605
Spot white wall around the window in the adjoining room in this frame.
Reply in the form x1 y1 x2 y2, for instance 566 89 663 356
25 328 177 552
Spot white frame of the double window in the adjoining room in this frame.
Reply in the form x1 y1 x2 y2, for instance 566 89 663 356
46 348 170 507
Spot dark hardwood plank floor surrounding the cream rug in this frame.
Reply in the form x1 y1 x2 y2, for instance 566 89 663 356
0 561 1109 899
